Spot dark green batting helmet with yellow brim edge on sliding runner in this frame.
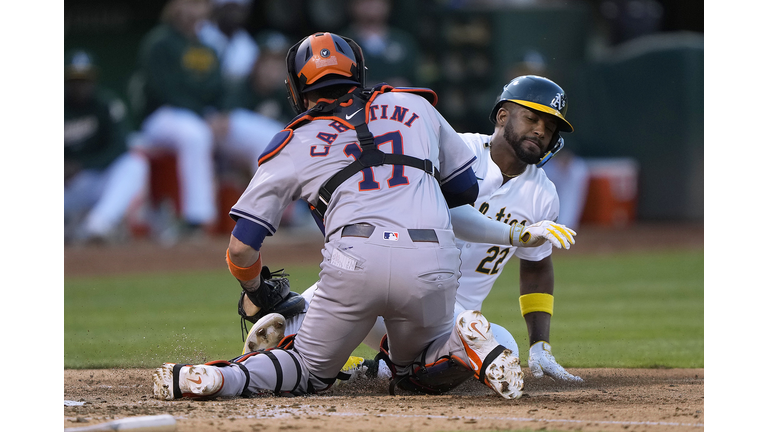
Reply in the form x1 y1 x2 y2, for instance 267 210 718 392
491 75 573 168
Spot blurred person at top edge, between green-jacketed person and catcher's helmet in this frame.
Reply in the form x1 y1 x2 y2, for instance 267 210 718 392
198 0 259 83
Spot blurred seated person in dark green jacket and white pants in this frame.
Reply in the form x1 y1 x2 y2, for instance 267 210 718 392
134 0 224 236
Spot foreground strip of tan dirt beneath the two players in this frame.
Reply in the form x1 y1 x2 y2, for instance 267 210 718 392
64 369 704 432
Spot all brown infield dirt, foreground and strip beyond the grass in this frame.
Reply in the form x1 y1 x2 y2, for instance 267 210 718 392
64 224 704 432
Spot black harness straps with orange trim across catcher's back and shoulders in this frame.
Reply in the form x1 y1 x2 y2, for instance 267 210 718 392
286 85 440 219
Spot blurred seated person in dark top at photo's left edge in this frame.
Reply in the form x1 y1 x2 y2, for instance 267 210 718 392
64 49 149 244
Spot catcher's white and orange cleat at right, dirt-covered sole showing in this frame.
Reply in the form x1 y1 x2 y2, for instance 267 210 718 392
456 311 523 399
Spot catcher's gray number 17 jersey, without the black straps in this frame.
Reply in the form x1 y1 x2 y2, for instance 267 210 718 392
232 93 474 239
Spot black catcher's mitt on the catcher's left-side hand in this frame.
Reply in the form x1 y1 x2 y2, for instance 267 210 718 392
237 266 305 340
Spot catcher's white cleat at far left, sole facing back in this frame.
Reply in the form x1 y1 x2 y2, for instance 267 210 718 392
152 363 224 400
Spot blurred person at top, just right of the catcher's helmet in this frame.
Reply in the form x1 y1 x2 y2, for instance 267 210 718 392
342 0 420 87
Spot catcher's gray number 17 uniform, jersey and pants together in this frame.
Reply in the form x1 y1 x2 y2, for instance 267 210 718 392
231 92 475 391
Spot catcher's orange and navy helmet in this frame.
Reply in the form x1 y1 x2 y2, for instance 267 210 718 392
285 33 365 114
